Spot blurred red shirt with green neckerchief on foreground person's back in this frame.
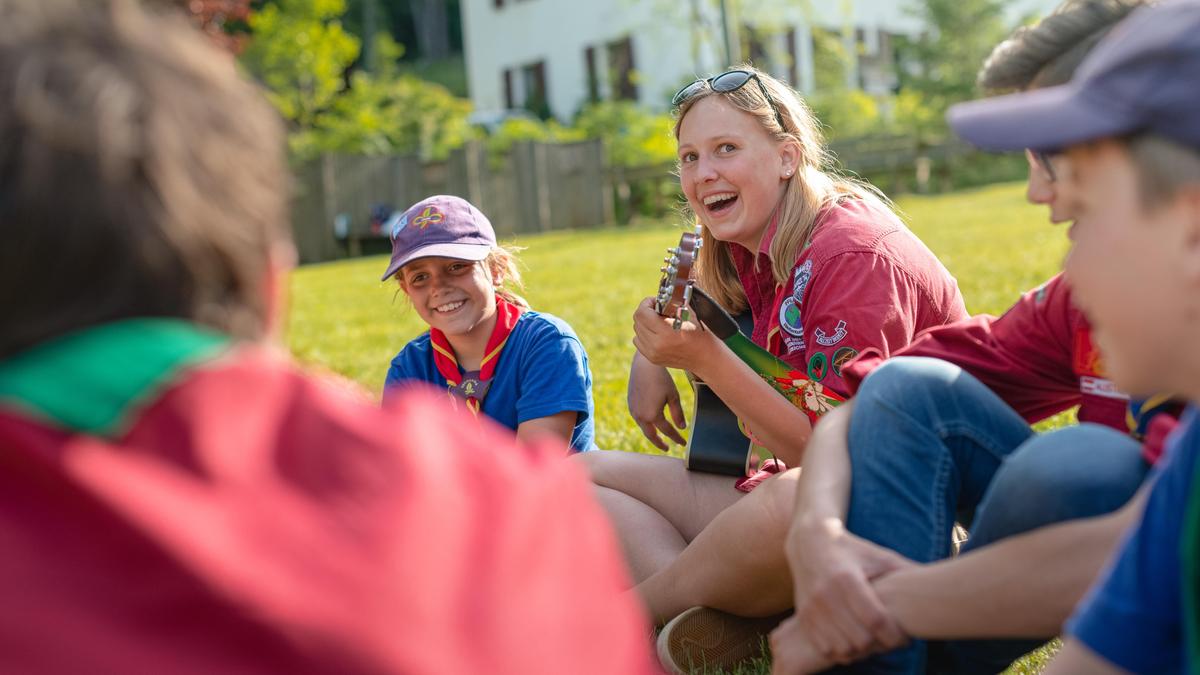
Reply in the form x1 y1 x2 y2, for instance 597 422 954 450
0 321 656 675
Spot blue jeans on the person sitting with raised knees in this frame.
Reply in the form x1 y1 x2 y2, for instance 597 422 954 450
846 358 1148 673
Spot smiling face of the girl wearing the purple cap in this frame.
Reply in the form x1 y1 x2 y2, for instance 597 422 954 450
400 257 500 341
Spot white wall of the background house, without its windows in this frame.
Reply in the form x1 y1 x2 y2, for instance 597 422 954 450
462 0 1057 120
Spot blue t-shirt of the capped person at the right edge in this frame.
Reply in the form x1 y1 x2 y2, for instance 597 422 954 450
1067 406 1200 673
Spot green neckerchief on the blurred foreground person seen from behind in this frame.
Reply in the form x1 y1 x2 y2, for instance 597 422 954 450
0 318 229 437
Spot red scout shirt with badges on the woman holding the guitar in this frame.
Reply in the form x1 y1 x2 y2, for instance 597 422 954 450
730 198 967 395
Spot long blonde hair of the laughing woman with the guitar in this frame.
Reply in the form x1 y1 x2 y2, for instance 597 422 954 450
674 65 890 312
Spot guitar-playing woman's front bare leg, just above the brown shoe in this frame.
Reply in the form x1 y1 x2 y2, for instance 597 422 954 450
636 468 799 623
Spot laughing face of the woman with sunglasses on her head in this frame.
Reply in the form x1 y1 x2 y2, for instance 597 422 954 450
678 95 799 251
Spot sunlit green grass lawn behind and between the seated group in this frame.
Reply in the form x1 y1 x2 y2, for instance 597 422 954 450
288 184 1067 673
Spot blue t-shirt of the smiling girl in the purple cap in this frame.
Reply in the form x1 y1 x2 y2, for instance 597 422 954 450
383 311 595 452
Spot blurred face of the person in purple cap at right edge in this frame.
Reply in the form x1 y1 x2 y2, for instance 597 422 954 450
1064 141 1200 395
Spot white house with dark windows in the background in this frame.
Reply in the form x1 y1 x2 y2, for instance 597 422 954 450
462 0 1058 120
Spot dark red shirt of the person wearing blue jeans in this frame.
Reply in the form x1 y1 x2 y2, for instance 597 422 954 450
845 269 1172 462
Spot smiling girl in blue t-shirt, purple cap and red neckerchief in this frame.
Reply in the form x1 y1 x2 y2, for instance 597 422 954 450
383 195 595 452
